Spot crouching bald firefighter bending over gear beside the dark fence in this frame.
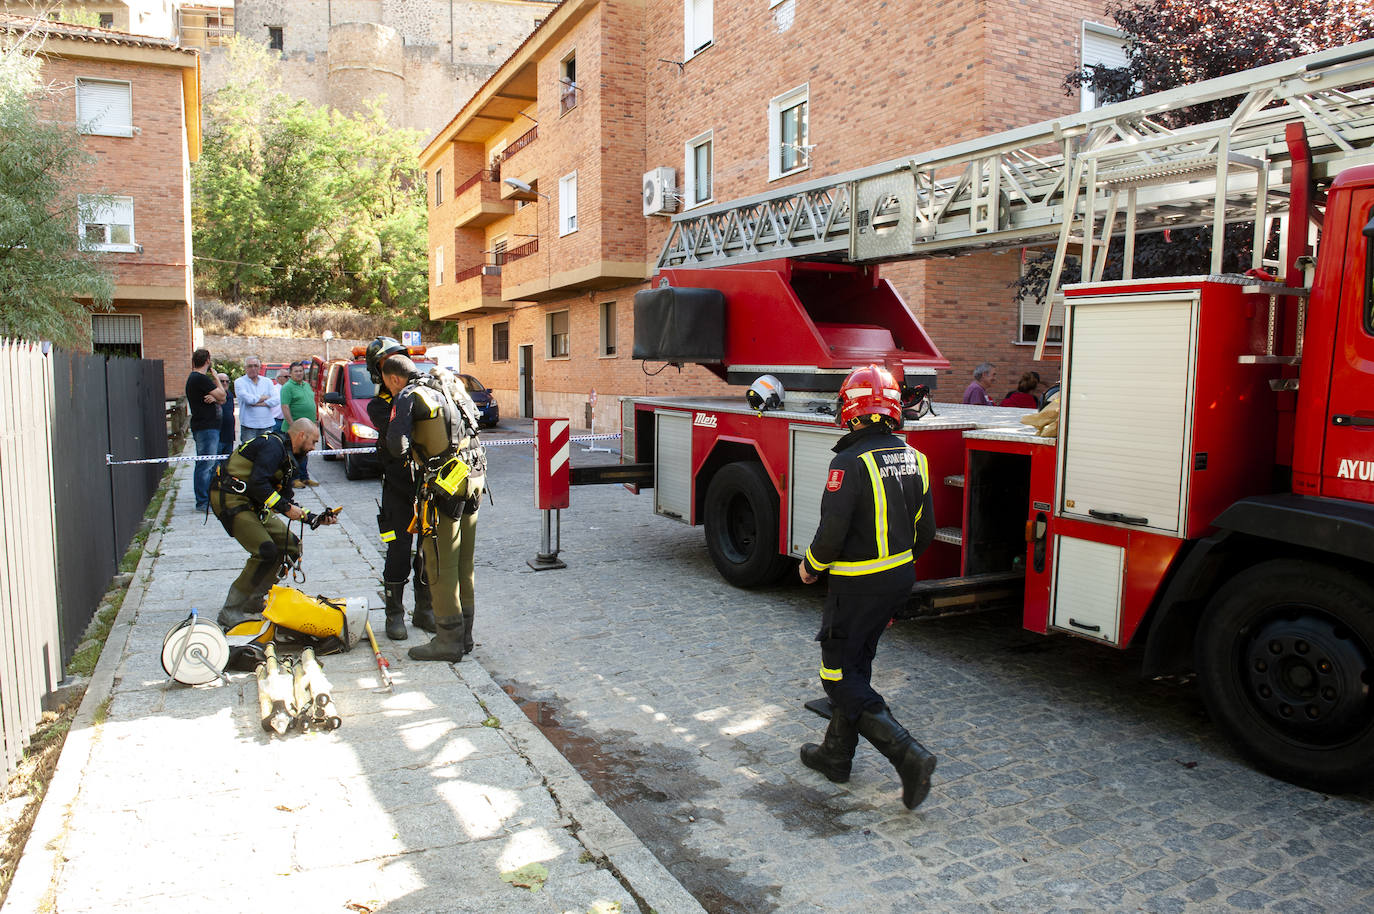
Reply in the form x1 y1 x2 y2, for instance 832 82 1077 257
210 419 338 631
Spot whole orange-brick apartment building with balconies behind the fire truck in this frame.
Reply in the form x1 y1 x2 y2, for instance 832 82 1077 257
422 0 1120 426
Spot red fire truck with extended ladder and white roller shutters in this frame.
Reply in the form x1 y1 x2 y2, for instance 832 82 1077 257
621 41 1374 789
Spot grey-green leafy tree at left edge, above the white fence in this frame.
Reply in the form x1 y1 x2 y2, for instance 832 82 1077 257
0 28 114 348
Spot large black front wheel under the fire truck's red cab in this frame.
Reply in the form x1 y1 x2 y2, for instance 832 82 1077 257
1197 559 1374 790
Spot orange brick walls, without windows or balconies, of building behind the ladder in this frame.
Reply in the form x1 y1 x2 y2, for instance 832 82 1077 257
427 0 1107 422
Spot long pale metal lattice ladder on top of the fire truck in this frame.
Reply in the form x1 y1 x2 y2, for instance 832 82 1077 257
658 40 1374 357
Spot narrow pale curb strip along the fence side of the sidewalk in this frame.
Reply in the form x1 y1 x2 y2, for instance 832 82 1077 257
3 463 192 914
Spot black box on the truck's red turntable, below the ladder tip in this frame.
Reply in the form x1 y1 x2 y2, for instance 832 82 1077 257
632 286 725 363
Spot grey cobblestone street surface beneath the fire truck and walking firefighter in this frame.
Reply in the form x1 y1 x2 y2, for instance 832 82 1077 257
321 423 1374 914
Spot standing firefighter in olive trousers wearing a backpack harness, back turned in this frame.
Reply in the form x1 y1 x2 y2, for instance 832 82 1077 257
382 355 486 662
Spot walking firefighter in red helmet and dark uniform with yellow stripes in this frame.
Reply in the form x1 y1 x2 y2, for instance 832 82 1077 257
797 366 936 810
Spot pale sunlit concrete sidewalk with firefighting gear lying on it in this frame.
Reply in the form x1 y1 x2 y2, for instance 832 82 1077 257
4 442 702 914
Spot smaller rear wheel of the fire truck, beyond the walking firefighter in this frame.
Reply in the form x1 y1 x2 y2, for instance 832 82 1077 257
706 460 791 587
